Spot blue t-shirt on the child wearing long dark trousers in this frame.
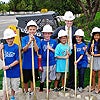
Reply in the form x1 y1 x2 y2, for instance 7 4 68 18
76 43 88 68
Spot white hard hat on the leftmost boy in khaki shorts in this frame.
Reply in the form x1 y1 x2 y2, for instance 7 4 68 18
3 28 16 39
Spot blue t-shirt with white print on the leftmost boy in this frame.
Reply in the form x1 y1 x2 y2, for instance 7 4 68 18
4 44 20 78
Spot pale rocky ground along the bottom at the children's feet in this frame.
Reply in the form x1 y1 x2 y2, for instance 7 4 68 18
0 87 100 100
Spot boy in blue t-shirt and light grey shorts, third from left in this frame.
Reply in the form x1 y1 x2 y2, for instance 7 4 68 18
40 25 57 92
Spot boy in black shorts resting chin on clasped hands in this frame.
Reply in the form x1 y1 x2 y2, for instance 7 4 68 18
22 20 40 95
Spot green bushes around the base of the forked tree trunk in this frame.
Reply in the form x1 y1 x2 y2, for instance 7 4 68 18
74 12 100 40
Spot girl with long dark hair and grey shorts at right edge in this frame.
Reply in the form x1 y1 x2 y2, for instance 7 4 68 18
88 27 100 93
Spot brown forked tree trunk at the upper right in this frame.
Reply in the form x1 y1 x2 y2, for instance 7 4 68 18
76 0 100 22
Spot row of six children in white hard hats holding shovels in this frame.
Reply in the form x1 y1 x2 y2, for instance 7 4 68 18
0 20 100 100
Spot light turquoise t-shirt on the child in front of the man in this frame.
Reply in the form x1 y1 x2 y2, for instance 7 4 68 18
55 43 71 72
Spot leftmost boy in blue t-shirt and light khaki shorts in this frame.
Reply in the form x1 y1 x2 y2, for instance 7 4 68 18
0 29 20 100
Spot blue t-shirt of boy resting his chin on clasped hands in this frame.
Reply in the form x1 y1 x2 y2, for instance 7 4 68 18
22 35 41 69
